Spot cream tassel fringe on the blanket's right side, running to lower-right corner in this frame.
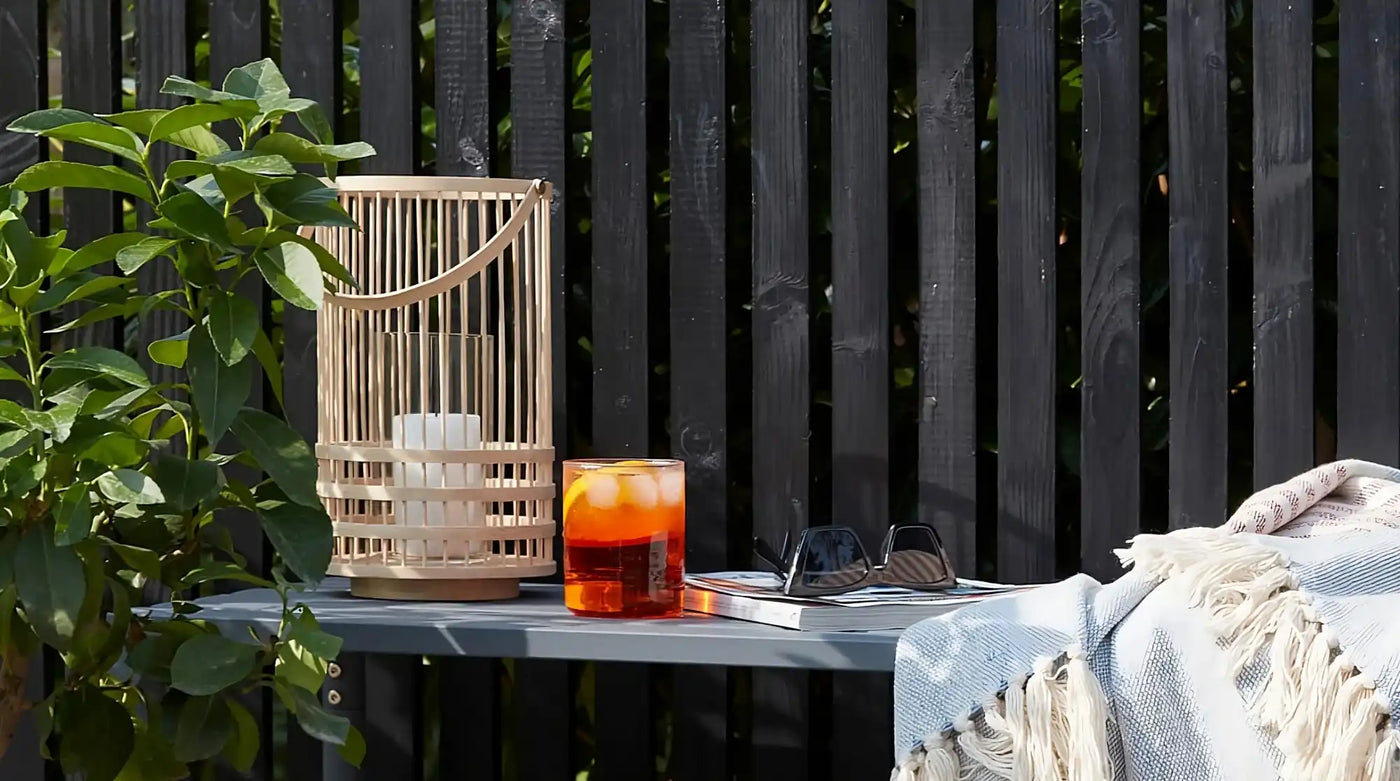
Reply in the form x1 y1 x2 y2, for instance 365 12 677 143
1119 529 1400 781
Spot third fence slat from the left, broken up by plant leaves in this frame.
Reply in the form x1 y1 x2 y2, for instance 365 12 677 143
136 0 195 382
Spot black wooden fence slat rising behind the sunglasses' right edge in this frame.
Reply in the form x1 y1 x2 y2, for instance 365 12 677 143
916 0 977 574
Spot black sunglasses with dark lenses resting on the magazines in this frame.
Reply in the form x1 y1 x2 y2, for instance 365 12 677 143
753 523 958 596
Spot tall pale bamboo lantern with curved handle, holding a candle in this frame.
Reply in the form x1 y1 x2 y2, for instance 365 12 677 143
314 176 556 600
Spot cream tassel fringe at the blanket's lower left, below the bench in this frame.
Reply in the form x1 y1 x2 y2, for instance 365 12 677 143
890 649 1113 781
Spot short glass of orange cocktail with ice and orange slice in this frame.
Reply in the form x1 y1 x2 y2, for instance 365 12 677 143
564 459 686 619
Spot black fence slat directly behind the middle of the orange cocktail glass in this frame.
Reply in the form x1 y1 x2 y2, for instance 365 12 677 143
591 0 654 780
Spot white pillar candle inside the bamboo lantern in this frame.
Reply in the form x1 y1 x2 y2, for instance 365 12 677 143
392 413 483 558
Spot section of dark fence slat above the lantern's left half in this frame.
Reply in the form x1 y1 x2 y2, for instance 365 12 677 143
360 0 419 174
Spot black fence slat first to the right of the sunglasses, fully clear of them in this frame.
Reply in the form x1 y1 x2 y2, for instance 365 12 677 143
997 0 1057 582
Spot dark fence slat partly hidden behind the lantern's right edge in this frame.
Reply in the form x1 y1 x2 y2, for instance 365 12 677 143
511 0 573 781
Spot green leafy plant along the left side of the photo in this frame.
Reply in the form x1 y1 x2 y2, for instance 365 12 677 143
0 60 374 781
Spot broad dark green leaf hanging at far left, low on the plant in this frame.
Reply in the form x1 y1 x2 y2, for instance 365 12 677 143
14 526 87 651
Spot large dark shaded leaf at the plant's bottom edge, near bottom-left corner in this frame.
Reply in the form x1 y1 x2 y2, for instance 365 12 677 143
57 686 136 781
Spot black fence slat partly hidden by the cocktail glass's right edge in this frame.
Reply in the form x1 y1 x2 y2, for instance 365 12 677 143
671 0 731 781
